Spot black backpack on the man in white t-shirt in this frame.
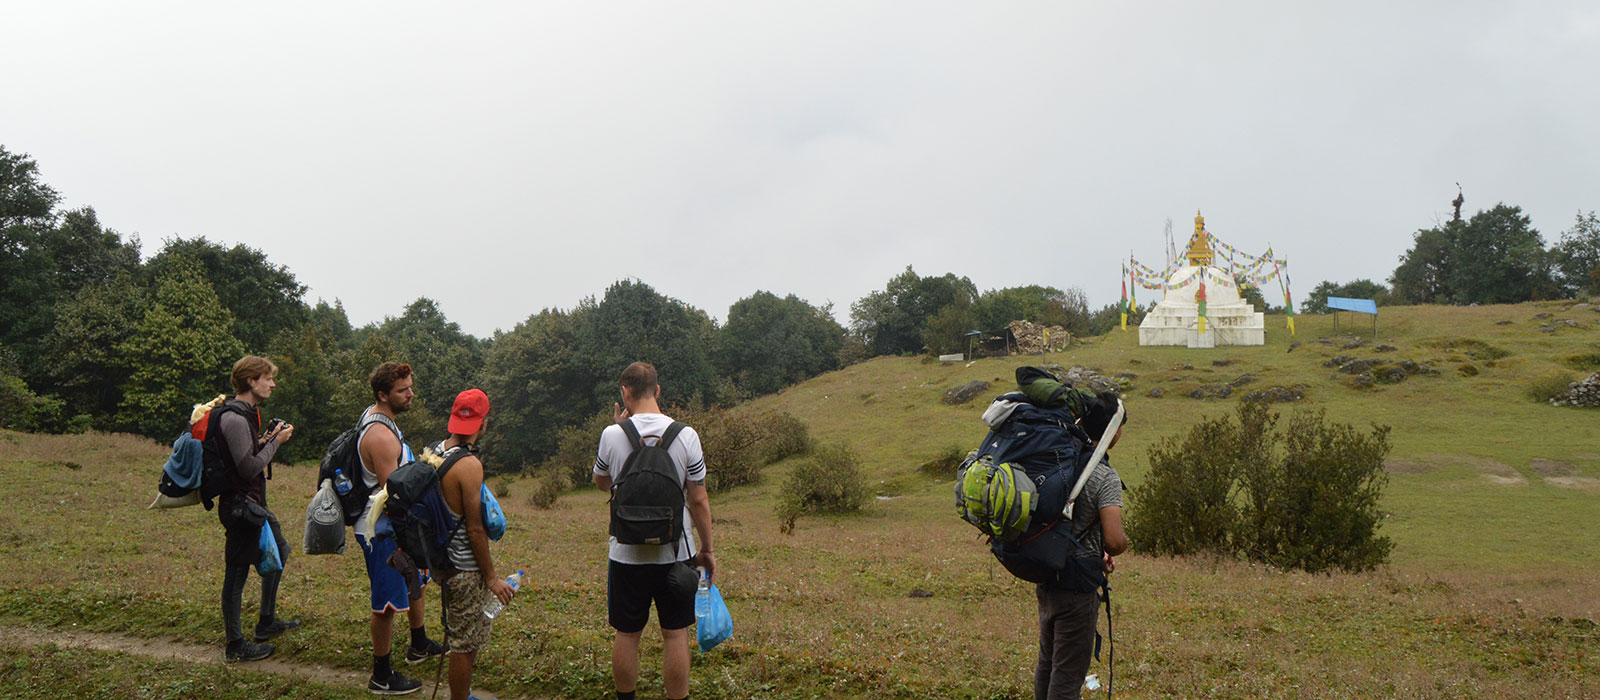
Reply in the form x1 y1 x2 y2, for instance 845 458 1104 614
611 419 683 545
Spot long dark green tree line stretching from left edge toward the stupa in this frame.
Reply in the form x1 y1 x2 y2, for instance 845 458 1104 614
0 147 1115 471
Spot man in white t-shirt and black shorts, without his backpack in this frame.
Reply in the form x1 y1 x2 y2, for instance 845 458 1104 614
594 363 717 700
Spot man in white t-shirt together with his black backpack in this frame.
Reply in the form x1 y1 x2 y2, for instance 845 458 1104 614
594 363 717 700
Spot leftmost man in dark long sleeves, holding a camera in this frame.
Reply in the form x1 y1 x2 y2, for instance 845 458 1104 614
202 355 299 662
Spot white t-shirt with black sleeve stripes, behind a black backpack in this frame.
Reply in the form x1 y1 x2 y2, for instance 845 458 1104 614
594 414 706 564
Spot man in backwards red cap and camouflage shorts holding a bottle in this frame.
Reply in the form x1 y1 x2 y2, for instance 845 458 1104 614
429 388 515 700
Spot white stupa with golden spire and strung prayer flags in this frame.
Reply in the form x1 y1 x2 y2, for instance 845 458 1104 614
1123 213 1294 347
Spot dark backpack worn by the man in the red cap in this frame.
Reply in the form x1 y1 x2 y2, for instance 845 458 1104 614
384 444 478 579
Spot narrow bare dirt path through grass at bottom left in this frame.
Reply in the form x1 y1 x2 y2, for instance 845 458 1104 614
0 626 547 700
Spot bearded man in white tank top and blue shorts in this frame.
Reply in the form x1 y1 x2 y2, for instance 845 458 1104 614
355 363 443 695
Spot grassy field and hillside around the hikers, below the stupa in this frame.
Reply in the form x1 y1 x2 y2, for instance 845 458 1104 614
0 304 1600 700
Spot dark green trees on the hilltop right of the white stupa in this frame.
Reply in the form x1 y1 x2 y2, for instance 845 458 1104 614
1304 203 1600 313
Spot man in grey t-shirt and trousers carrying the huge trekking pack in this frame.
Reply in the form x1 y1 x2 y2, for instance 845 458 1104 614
1034 392 1128 700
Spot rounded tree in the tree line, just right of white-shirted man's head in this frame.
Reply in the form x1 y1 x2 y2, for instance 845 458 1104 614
715 291 845 395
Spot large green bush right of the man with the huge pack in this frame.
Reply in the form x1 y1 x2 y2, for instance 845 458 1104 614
1128 403 1394 572
